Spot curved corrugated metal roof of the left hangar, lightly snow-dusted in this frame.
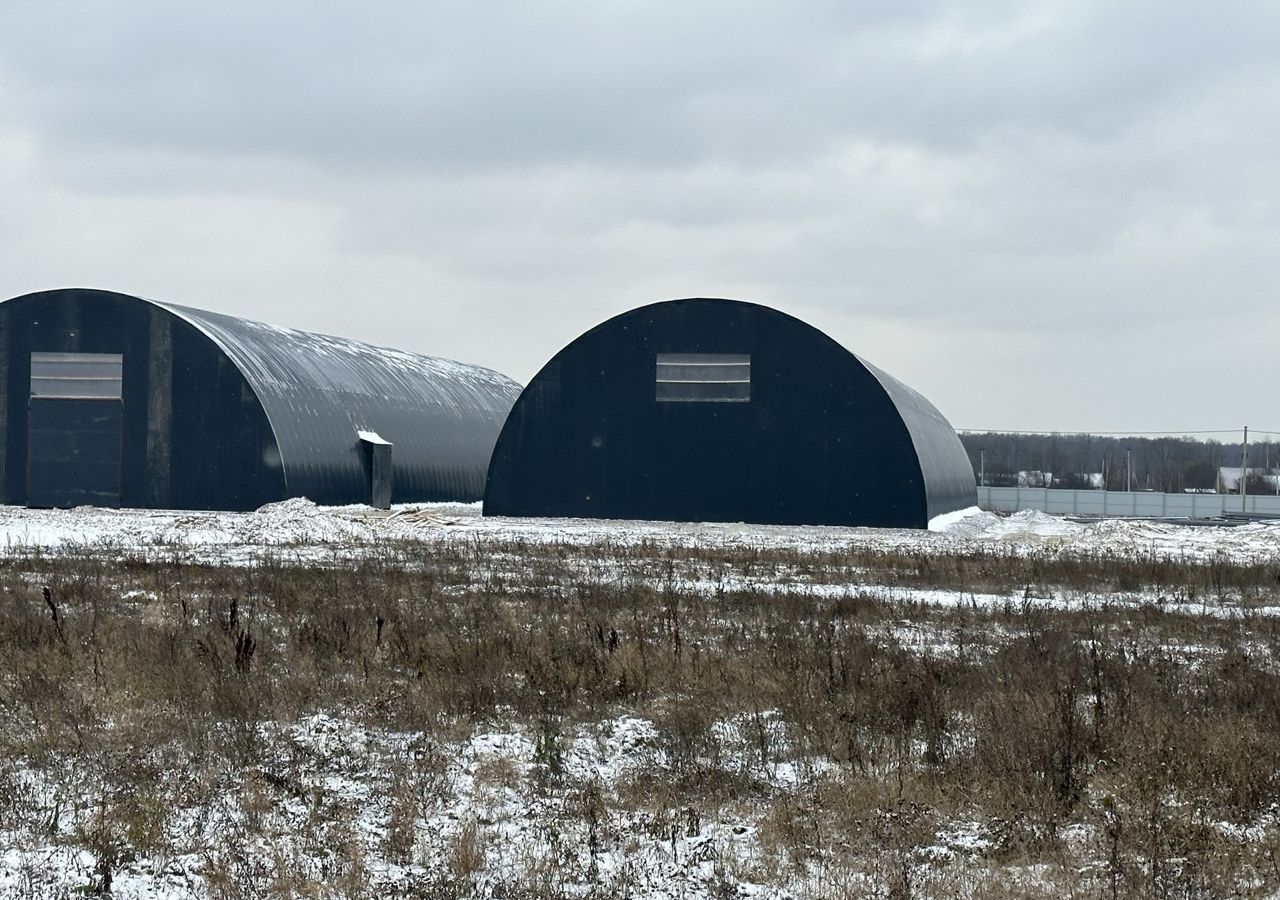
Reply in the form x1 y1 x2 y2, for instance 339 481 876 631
151 301 520 503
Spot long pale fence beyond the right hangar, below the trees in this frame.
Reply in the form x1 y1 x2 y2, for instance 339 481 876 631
978 486 1280 518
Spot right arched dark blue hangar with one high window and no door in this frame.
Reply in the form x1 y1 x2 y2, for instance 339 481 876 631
484 300 977 527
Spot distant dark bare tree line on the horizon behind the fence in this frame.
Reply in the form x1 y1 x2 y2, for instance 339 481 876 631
960 431 1280 494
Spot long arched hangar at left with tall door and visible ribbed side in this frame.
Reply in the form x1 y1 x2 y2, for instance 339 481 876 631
0 288 520 510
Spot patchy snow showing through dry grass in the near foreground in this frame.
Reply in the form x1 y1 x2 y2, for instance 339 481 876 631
0 714 890 900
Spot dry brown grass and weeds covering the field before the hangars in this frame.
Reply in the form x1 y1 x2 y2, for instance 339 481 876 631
0 543 1280 897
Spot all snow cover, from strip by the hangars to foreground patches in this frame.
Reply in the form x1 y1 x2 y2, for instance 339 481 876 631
0 499 1280 900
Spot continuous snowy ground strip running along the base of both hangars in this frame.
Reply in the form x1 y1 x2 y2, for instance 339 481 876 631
0 499 1280 563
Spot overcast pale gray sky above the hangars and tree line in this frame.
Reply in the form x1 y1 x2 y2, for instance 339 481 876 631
0 0 1280 431
